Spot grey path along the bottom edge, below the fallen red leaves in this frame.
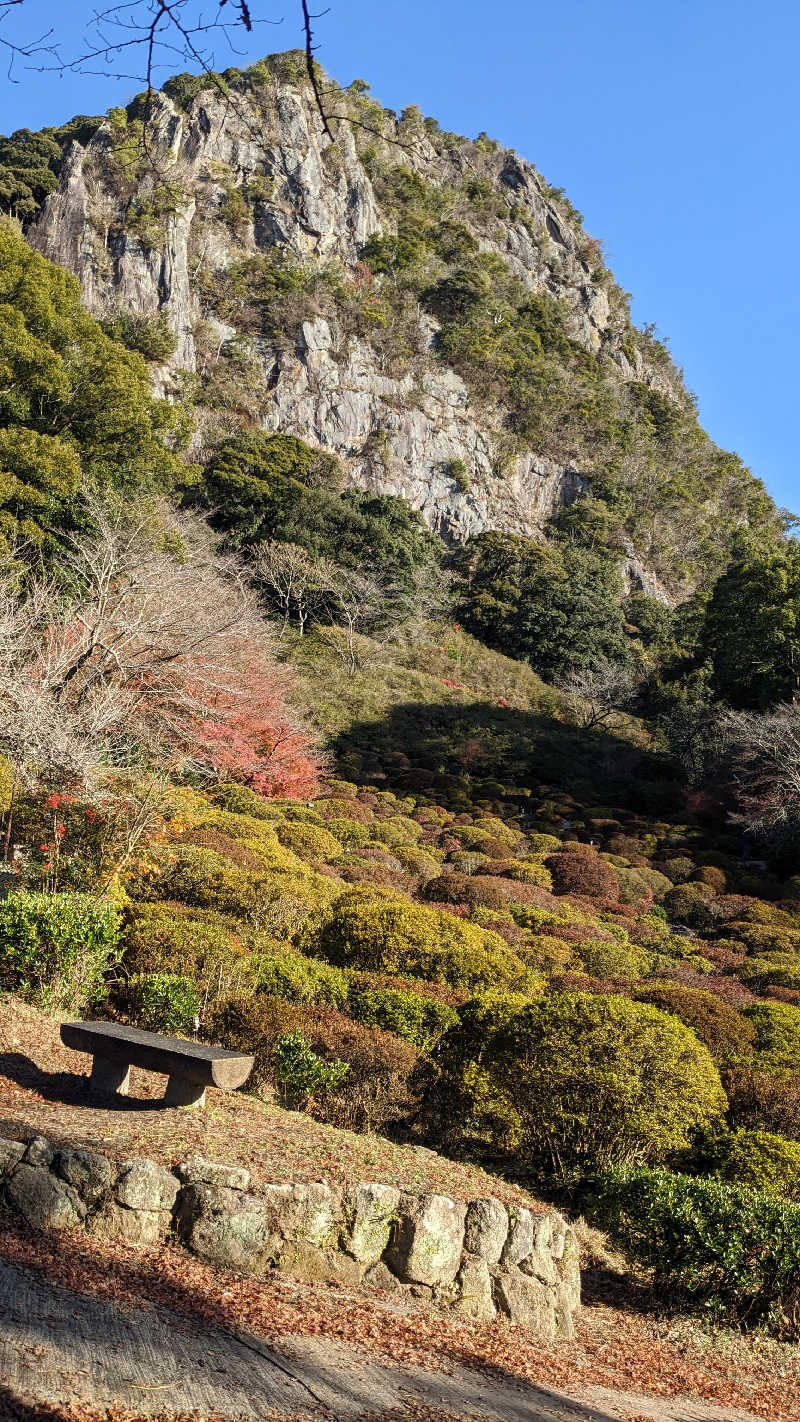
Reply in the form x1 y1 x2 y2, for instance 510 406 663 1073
0 1261 757 1422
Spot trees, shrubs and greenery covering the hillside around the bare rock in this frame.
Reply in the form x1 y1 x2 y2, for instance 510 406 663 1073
0 55 800 1338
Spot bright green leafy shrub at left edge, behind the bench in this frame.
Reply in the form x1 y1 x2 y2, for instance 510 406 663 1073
0 890 119 1011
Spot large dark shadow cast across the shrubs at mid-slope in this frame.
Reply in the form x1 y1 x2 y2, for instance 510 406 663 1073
333 701 683 816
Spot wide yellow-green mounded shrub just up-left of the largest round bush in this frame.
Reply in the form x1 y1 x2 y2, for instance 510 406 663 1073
314 889 524 988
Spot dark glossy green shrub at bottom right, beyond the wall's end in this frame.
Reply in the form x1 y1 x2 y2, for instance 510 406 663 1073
588 1169 800 1340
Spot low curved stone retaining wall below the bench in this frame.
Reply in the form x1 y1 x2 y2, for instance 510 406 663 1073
0 1136 580 1340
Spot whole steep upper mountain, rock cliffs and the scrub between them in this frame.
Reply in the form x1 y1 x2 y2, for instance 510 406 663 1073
18 53 774 600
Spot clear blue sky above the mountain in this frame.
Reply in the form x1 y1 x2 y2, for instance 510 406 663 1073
0 0 800 509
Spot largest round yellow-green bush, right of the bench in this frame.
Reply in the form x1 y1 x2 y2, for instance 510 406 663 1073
449 993 725 1179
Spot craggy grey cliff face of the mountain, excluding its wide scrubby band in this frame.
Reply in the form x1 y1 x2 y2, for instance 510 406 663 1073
28 57 713 592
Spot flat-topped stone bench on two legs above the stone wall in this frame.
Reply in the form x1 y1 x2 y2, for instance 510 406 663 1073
61 1022 253 1106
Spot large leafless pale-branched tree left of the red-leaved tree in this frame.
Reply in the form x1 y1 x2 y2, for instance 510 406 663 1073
0 494 269 789
